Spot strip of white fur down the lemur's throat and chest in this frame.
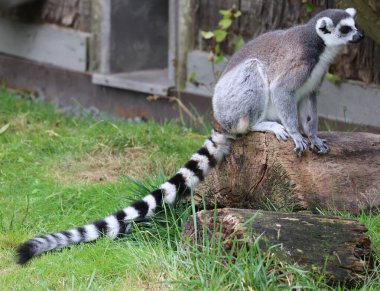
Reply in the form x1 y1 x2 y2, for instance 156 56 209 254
295 46 342 101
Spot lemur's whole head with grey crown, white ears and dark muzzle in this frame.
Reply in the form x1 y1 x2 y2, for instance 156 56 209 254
312 8 364 46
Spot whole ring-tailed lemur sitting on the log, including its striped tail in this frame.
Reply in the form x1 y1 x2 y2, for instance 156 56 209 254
17 8 363 264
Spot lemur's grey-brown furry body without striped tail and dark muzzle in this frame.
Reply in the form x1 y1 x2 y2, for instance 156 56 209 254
213 9 364 155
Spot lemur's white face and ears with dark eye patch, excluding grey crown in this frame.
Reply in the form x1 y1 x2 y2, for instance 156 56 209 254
315 8 364 46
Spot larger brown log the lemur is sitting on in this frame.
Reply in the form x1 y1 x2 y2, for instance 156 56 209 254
195 132 380 213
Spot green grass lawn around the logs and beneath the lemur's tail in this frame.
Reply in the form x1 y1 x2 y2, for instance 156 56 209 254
0 90 380 290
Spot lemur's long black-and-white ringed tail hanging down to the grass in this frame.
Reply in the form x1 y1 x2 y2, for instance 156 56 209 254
17 130 231 264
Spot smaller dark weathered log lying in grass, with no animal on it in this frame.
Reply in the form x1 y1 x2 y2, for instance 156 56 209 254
183 208 370 285
